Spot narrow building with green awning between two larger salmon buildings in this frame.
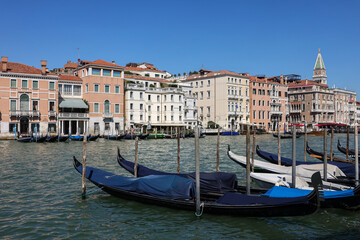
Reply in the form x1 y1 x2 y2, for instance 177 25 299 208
58 75 89 135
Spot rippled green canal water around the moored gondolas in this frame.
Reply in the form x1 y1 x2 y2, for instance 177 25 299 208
0 134 360 239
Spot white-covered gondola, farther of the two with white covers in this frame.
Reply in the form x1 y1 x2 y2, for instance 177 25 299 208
227 146 349 190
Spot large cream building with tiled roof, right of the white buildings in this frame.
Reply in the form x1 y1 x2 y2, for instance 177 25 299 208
183 69 250 131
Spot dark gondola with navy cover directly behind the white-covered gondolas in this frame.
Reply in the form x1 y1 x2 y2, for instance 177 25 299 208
256 145 355 186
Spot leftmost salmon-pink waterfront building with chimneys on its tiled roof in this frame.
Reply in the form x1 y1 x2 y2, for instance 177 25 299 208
0 57 59 136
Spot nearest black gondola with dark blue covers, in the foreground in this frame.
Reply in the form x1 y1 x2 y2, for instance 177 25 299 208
73 157 320 217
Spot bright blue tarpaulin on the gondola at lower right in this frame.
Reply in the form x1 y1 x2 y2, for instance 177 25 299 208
263 186 354 199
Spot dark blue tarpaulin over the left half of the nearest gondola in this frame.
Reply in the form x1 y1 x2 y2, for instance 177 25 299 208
77 167 195 199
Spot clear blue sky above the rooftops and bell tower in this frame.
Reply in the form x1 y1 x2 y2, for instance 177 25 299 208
0 0 360 94
